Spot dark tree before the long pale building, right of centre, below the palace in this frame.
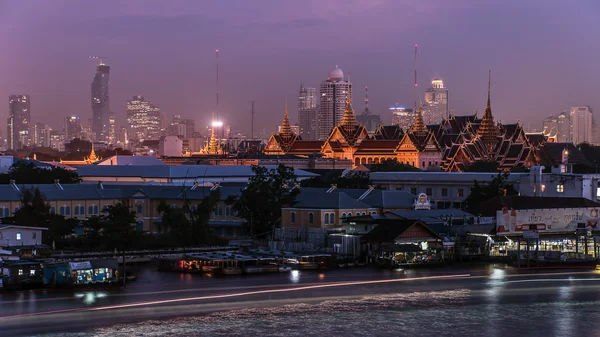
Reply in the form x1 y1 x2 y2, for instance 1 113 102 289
463 173 517 214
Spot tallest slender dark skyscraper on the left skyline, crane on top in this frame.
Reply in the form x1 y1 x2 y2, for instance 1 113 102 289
92 62 110 142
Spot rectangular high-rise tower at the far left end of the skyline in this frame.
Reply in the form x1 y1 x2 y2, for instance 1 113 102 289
6 95 31 150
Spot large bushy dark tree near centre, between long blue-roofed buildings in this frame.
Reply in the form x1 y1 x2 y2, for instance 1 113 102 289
227 165 298 237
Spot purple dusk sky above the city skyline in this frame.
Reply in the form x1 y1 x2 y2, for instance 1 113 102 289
0 0 600 134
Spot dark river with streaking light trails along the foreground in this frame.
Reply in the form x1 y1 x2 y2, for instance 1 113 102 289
0 265 600 336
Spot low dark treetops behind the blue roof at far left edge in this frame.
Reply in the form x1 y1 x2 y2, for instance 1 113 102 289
0 162 81 185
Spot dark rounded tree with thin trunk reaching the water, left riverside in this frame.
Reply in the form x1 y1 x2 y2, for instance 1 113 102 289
102 202 137 286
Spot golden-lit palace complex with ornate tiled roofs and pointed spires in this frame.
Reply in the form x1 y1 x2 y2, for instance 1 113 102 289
265 71 546 172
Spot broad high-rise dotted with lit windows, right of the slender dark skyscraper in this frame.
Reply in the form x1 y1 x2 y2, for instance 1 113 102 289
127 96 161 141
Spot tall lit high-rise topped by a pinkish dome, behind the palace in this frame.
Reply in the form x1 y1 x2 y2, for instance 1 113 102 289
318 66 352 139
